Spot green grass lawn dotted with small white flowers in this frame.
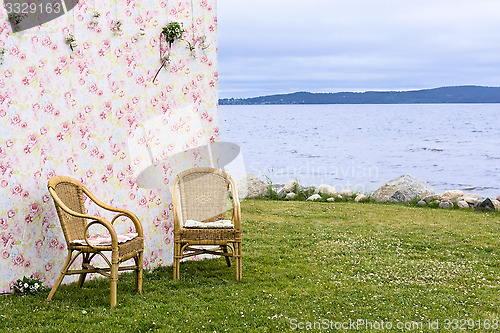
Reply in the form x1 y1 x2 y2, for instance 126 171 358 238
0 200 500 332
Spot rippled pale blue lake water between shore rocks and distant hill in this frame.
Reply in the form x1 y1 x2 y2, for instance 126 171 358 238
219 104 500 197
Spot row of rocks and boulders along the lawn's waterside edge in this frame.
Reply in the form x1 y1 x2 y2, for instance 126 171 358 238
237 174 500 211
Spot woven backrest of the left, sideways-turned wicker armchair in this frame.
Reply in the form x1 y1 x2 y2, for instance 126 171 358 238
48 176 87 243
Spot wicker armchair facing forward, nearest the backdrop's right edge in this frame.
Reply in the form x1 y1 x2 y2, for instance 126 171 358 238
171 168 242 281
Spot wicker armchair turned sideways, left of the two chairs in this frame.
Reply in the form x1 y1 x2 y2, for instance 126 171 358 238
47 176 144 307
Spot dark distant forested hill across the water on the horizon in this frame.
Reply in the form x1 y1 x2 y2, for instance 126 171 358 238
219 86 500 105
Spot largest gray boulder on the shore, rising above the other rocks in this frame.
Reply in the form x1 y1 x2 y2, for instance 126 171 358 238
372 175 435 202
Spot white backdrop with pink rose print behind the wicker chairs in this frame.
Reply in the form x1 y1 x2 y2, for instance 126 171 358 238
0 0 218 292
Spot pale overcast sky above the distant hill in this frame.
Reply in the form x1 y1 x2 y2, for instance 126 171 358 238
217 0 500 98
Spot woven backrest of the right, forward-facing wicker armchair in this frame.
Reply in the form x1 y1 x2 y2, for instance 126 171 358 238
172 168 231 222
